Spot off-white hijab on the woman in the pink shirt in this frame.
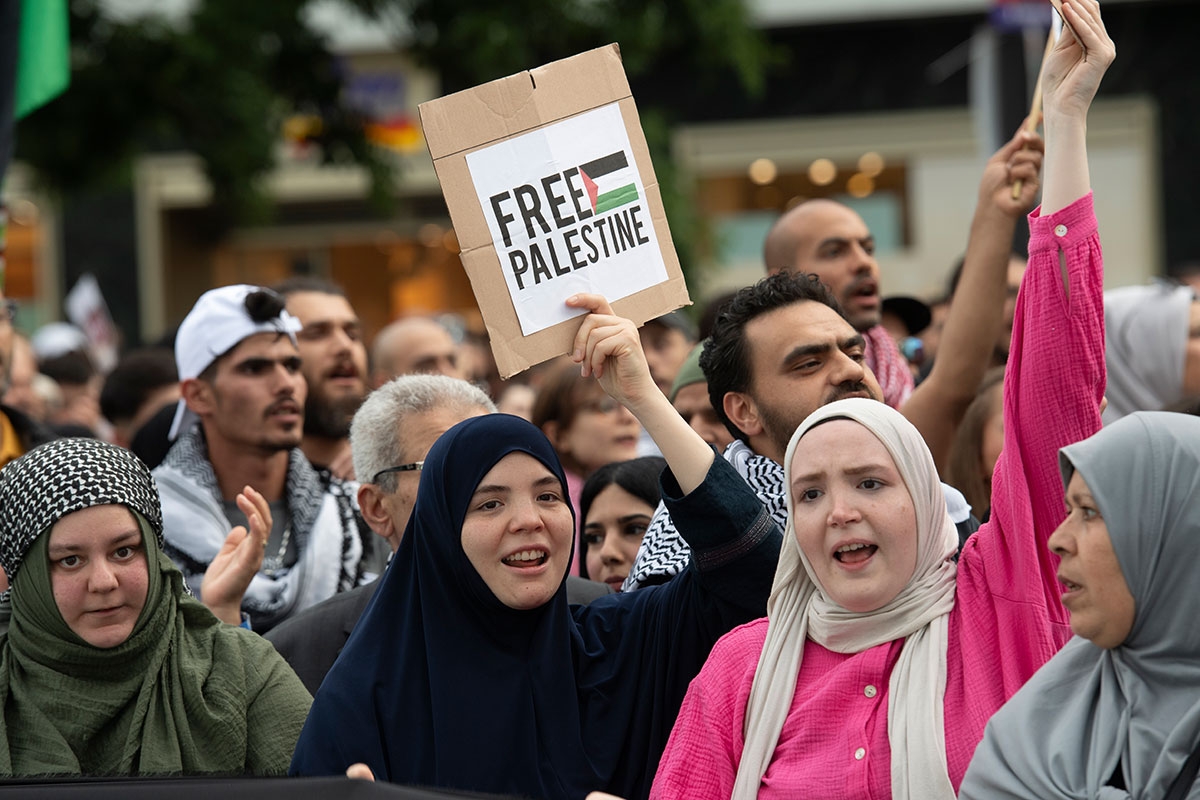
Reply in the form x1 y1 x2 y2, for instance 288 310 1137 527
733 398 958 800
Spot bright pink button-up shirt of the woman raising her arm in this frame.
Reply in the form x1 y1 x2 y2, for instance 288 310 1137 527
650 194 1105 800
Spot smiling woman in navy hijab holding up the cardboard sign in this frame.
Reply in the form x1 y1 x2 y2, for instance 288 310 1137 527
292 301 780 799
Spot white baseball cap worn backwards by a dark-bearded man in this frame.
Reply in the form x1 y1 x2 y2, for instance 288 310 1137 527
167 283 301 440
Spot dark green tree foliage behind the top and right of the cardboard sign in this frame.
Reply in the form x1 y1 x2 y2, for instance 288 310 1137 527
352 0 779 278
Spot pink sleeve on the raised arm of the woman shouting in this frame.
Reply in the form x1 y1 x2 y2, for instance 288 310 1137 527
959 194 1105 696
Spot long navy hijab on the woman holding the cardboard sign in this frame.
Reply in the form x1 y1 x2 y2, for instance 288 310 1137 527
292 414 642 798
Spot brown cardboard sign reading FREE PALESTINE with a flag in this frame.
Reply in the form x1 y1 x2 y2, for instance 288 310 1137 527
420 44 690 378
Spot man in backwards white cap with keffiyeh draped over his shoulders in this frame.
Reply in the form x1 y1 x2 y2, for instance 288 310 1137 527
154 285 366 632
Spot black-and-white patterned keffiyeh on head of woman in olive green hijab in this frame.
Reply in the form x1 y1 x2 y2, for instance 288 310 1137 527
0 438 162 583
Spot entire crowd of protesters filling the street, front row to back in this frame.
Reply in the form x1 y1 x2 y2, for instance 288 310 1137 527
0 0 1200 800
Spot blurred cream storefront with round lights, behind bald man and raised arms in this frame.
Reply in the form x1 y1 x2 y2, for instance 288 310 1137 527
674 97 1163 299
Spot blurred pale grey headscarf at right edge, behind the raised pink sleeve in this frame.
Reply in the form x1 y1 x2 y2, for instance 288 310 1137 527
1104 282 1195 425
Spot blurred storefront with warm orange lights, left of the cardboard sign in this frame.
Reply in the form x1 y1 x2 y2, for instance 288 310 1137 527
134 54 481 339
